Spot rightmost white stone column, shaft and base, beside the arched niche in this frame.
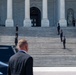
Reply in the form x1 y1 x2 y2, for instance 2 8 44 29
58 0 67 27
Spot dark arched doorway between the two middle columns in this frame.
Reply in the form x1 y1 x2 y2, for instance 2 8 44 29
30 7 41 27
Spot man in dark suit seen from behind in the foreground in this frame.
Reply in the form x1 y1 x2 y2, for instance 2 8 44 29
8 39 33 75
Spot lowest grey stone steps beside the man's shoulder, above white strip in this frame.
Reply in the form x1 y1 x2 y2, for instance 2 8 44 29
33 55 76 67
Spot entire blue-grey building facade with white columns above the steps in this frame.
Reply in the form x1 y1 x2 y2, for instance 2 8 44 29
0 0 76 27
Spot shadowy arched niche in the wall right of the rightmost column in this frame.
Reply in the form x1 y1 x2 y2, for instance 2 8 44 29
67 8 75 26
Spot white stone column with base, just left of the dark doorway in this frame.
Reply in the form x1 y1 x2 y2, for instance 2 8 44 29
24 0 31 27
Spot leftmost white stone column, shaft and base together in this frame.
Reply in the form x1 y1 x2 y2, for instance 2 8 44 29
5 0 14 27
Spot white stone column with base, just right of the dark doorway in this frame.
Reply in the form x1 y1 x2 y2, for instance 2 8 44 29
41 0 49 27
